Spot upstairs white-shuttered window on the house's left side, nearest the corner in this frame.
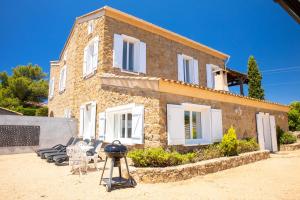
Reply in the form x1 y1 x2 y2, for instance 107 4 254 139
83 36 100 79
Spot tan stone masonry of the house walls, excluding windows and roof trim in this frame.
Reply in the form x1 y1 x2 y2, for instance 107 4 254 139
48 7 287 147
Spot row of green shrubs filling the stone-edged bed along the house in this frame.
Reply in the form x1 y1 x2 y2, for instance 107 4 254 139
128 127 259 167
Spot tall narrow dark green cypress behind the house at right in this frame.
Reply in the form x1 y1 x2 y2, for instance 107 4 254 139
248 56 265 99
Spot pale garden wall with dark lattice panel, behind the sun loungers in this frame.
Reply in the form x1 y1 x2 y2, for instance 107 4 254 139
0 115 77 154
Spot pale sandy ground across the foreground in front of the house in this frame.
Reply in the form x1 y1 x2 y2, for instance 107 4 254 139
0 151 300 200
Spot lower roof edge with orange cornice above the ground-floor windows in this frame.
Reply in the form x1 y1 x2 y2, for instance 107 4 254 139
101 73 289 112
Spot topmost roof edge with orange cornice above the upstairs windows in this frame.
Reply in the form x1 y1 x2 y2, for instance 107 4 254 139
59 6 229 60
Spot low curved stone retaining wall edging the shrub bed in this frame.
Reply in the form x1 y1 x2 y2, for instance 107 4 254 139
129 150 270 183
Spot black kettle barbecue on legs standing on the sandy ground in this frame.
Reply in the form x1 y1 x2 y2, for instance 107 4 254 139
100 140 135 192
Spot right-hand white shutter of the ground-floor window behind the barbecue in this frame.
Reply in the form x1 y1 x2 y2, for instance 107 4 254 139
132 105 144 144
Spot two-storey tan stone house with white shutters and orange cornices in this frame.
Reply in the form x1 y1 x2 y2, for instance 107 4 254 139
48 6 288 150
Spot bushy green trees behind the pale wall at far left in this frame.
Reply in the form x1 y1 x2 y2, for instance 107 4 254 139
0 64 48 115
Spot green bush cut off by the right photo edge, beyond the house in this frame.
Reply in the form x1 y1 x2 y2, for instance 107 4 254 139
288 101 300 131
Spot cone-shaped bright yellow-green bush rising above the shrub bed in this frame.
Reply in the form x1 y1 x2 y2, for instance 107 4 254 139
220 126 238 156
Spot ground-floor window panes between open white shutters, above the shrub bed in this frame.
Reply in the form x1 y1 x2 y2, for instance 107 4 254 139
184 111 202 139
